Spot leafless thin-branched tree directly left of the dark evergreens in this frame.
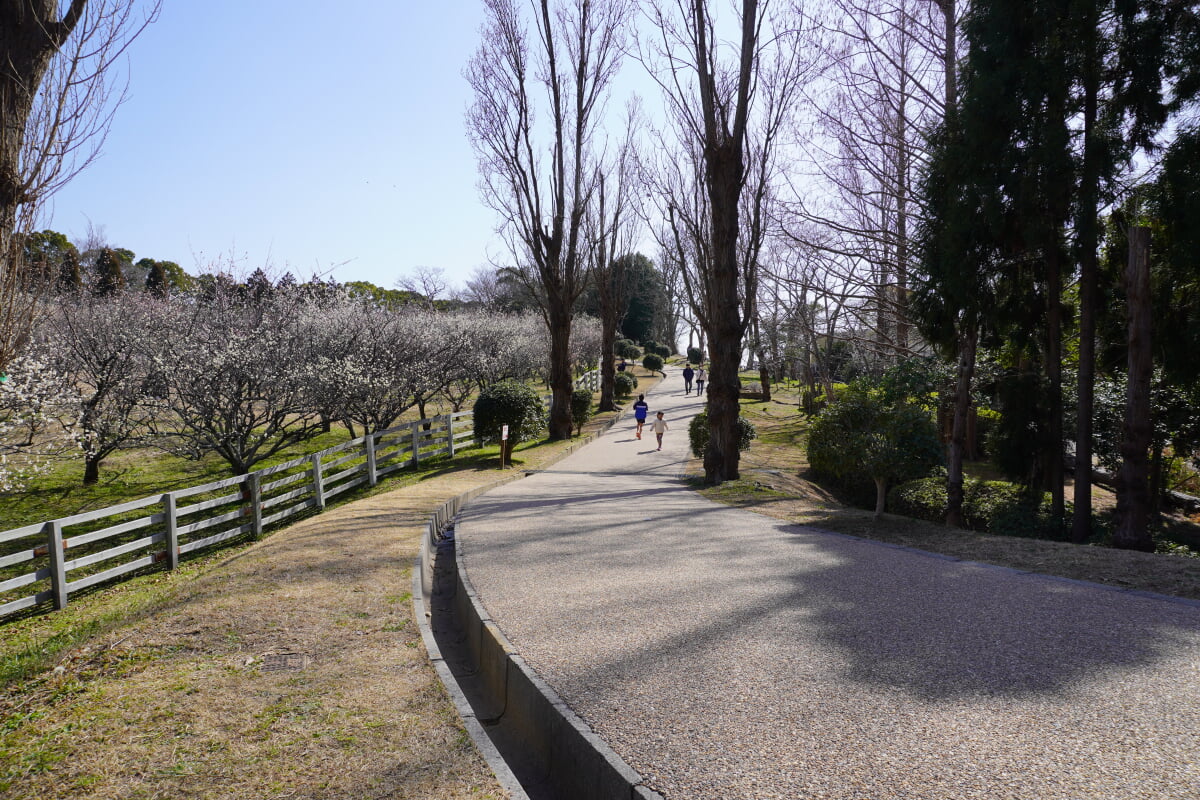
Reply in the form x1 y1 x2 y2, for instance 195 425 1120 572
790 0 954 360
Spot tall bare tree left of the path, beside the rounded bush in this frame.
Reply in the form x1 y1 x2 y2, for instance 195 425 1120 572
467 0 630 439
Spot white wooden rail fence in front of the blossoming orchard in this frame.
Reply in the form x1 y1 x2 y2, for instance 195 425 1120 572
0 411 474 619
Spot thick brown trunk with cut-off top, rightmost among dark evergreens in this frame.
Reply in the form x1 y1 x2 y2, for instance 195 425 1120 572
1112 227 1154 552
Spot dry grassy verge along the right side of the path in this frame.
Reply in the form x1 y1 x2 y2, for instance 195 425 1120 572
689 386 1200 600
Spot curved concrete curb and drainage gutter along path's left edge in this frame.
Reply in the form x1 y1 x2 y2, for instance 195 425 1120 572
413 411 662 800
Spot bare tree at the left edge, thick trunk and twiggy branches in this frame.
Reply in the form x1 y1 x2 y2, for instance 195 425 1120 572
0 0 161 369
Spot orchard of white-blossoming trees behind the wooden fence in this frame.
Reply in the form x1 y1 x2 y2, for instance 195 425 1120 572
0 281 600 492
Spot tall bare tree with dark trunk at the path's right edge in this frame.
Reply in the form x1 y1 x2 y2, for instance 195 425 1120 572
641 0 808 485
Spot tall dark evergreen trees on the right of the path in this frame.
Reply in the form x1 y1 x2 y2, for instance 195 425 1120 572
913 0 1200 549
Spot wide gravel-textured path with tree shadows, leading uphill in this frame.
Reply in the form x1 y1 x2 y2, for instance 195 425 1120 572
457 369 1200 800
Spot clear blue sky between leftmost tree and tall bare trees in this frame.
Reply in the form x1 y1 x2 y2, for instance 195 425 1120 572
46 0 506 287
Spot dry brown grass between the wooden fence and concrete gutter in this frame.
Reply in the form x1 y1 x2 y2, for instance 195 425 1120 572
0 407 644 800
